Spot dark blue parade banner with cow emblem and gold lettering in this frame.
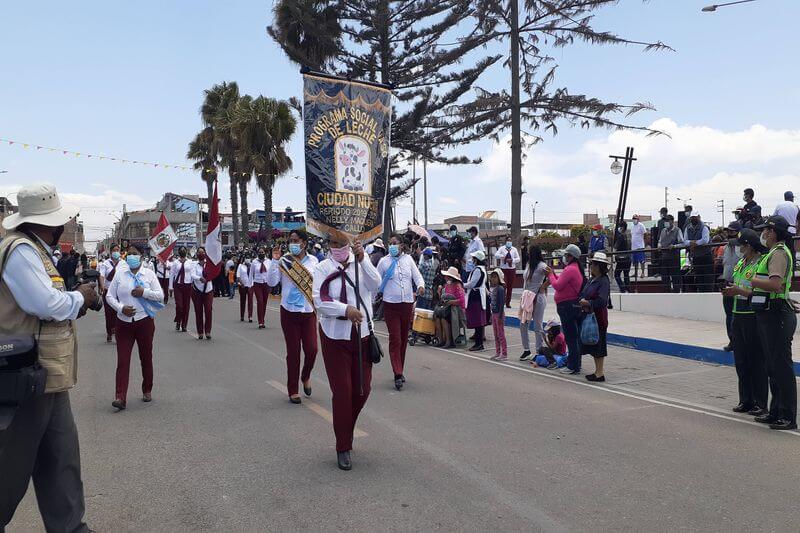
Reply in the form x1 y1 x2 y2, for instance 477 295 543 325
303 73 392 241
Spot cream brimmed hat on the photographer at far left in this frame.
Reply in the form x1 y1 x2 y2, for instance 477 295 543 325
3 183 79 230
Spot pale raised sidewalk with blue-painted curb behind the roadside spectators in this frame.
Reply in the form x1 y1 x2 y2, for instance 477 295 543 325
506 291 800 376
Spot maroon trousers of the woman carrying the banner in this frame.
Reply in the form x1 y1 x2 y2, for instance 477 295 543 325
319 328 372 452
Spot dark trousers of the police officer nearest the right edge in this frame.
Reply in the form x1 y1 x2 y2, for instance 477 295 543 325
756 306 797 422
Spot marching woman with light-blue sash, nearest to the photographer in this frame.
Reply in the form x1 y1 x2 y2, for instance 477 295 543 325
107 245 164 411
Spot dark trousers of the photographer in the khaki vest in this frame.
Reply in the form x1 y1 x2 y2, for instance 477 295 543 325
0 392 89 533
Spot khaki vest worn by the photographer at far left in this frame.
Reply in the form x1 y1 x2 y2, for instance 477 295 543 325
0 232 78 393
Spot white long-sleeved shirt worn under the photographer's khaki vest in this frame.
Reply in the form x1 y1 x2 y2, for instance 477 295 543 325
3 241 83 321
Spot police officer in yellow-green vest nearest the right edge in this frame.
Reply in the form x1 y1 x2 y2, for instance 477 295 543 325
750 216 797 429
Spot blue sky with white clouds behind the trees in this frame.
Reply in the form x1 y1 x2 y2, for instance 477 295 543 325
0 0 800 245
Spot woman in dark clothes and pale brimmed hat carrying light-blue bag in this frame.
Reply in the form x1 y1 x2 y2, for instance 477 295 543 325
578 252 611 381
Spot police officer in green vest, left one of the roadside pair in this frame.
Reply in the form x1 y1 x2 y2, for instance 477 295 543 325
722 229 769 416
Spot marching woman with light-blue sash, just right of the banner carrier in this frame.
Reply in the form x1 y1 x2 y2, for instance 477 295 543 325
378 235 425 390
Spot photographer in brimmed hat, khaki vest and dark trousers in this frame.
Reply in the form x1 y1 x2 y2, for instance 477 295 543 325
0 184 99 532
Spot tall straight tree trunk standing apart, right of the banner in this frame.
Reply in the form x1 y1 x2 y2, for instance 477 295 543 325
509 0 522 242
